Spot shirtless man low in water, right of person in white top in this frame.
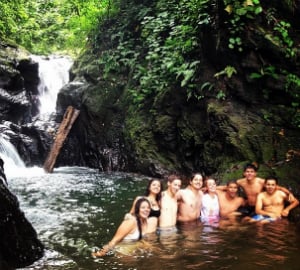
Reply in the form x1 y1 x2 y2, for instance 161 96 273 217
217 180 246 218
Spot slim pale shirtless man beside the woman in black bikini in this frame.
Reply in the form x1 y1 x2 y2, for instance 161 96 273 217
159 174 181 230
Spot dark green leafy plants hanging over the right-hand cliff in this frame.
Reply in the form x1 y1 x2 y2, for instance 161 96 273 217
88 0 298 116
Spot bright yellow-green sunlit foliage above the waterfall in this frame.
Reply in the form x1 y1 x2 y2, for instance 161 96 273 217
0 0 112 54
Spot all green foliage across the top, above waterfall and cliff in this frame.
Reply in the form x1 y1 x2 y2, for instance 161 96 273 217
0 0 300 125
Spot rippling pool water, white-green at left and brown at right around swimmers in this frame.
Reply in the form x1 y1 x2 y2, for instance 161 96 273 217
8 167 300 270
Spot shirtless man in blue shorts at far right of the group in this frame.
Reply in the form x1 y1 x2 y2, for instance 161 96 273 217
251 177 299 223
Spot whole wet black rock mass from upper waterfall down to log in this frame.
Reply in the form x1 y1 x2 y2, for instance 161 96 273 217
0 43 56 166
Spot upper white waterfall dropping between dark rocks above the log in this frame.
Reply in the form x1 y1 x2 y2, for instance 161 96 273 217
31 55 73 114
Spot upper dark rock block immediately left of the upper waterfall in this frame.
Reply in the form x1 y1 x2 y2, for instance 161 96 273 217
0 44 39 124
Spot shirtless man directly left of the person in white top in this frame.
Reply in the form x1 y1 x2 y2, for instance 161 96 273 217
176 173 203 222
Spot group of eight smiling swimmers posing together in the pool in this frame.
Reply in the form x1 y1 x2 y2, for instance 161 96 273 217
92 164 299 257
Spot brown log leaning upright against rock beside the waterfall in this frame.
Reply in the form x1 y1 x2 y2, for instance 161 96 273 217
43 106 80 173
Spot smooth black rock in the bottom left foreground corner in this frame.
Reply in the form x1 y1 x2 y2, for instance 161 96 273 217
0 159 44 269
